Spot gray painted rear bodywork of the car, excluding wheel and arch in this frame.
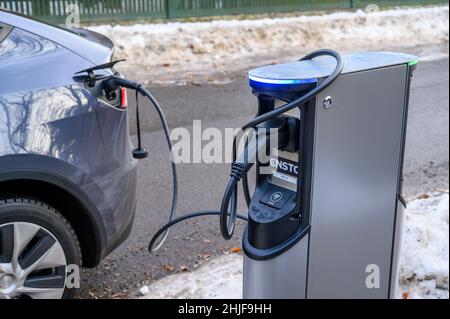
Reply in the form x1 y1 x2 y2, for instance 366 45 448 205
0 11 137 264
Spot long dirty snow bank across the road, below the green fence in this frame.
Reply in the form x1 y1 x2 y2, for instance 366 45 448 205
90 6 449 83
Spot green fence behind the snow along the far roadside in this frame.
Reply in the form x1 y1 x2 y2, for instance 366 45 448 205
0 0 448 23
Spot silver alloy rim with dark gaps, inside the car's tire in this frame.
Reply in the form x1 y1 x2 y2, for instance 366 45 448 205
0 222 67 299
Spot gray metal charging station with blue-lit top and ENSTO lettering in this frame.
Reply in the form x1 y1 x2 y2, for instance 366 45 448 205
243 52 417 298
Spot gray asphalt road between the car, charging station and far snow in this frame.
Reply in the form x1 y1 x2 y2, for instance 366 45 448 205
81 59 449 298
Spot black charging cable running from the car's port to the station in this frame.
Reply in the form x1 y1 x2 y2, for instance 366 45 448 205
109 49 344 252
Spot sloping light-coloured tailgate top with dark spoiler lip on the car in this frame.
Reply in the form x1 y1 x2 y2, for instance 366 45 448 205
0 10 114 65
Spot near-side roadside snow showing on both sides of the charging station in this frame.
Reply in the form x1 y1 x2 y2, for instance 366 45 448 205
140 192 449 299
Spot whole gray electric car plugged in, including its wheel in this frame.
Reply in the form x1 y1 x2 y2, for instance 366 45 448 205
0 10 136 299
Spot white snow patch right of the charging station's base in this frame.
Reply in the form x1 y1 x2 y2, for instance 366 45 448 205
400 194 449 298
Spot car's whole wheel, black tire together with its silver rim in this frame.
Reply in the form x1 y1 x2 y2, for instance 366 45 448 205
0 197 82 299
